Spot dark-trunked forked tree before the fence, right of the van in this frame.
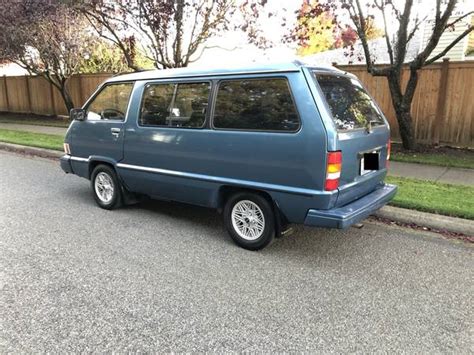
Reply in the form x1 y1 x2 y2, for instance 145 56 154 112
290 0 474 149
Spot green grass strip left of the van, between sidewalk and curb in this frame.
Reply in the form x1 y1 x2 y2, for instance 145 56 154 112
0 129 64 150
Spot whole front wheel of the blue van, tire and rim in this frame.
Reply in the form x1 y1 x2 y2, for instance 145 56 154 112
91 165 122 210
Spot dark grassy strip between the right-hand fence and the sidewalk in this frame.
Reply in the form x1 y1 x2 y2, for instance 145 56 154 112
390 148 474 169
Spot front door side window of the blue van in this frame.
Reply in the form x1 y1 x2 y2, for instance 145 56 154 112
86 83 133 121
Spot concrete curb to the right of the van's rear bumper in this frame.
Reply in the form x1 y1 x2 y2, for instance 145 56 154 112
374 206 474 236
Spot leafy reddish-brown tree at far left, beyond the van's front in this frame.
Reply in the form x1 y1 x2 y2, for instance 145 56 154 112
0 0 94 110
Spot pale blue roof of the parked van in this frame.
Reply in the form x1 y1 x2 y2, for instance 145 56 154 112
107 60 343 82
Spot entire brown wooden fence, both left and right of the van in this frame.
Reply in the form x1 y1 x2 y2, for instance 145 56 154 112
0 61 474 147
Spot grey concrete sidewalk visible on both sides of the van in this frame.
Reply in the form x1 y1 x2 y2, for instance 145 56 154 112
0 123 474 186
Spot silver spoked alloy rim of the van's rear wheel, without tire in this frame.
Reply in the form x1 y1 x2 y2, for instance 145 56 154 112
231 200 265 240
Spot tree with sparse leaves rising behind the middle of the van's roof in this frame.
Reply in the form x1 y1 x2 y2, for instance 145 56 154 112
78 0 241 71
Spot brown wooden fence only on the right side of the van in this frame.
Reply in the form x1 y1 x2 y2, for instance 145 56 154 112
338 60 474 147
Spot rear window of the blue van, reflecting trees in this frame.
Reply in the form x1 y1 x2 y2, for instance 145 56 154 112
314 73 384 130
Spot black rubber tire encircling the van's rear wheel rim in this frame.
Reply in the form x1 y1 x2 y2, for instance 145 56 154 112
223 192 275 250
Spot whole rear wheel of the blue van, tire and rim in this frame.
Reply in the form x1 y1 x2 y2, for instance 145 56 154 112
224 192 275 250
